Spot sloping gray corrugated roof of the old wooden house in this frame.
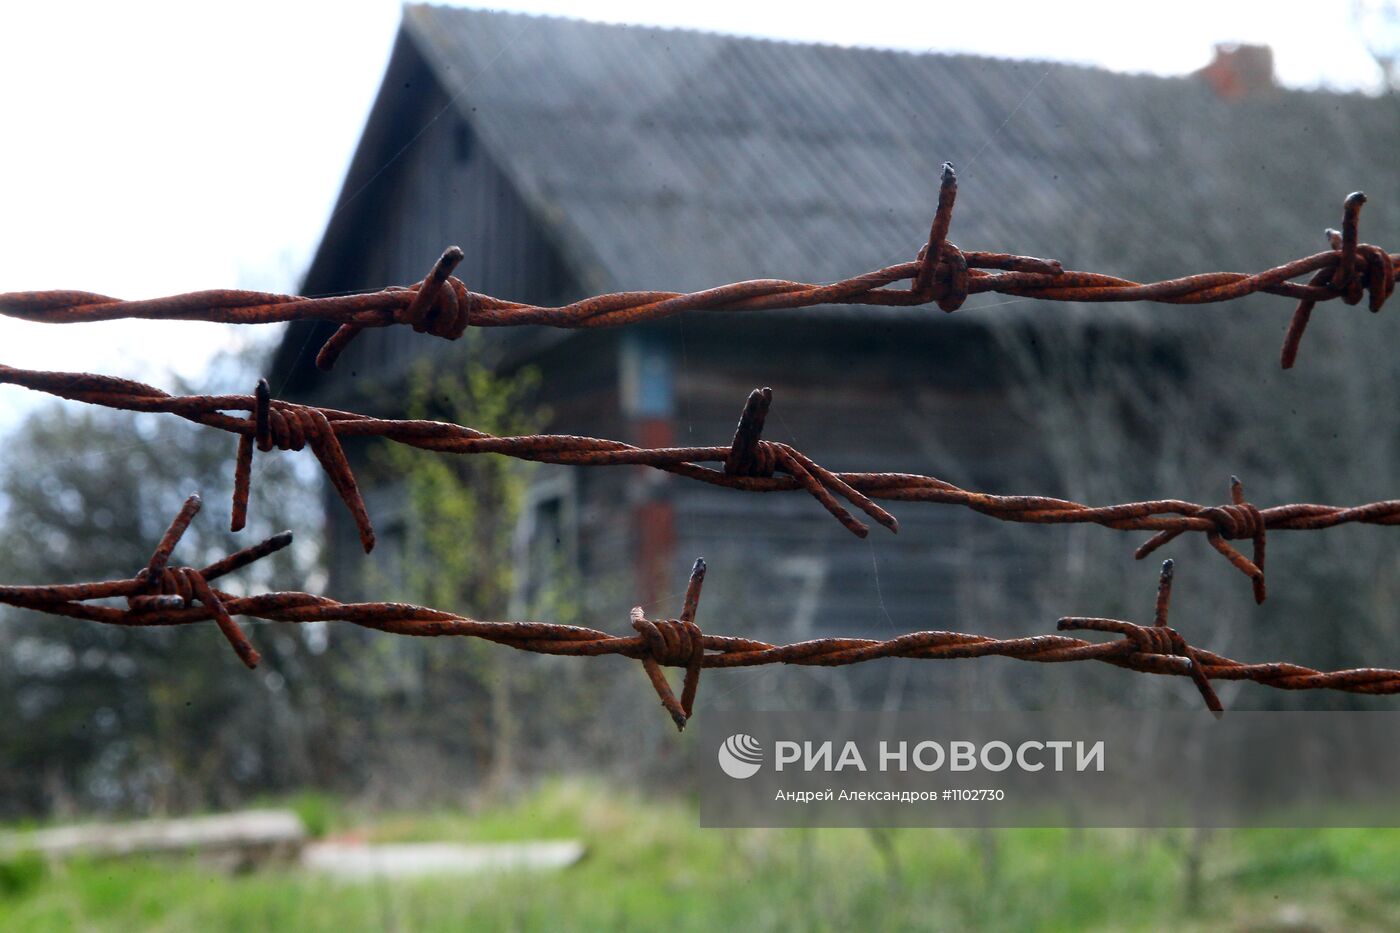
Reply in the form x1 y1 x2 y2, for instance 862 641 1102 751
301 6 1400 326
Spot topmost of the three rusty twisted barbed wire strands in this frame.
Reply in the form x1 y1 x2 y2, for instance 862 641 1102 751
0 163 1400 370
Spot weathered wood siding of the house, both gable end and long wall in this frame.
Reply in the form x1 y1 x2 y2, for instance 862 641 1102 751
301 43 1044 652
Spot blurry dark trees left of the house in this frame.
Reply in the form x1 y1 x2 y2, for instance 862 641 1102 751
0 353 316 813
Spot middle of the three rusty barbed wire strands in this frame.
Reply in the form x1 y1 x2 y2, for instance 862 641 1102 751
0 366 1400 602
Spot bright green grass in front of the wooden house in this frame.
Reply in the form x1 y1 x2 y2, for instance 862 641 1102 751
0 783 1400 933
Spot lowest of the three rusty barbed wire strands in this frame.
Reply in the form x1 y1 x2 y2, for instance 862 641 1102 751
0 496 1400 728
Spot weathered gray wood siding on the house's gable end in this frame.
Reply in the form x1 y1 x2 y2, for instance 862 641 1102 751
304 41 585 594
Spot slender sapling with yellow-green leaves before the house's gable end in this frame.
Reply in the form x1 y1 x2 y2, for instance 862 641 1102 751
339 360 571 796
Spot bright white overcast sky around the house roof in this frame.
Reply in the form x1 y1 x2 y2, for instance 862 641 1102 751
0 0 1383 427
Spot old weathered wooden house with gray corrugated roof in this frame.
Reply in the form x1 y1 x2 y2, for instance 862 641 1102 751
273 6 1397 661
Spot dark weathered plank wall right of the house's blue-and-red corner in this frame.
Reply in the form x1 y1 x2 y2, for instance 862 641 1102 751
649 318 1042 639
